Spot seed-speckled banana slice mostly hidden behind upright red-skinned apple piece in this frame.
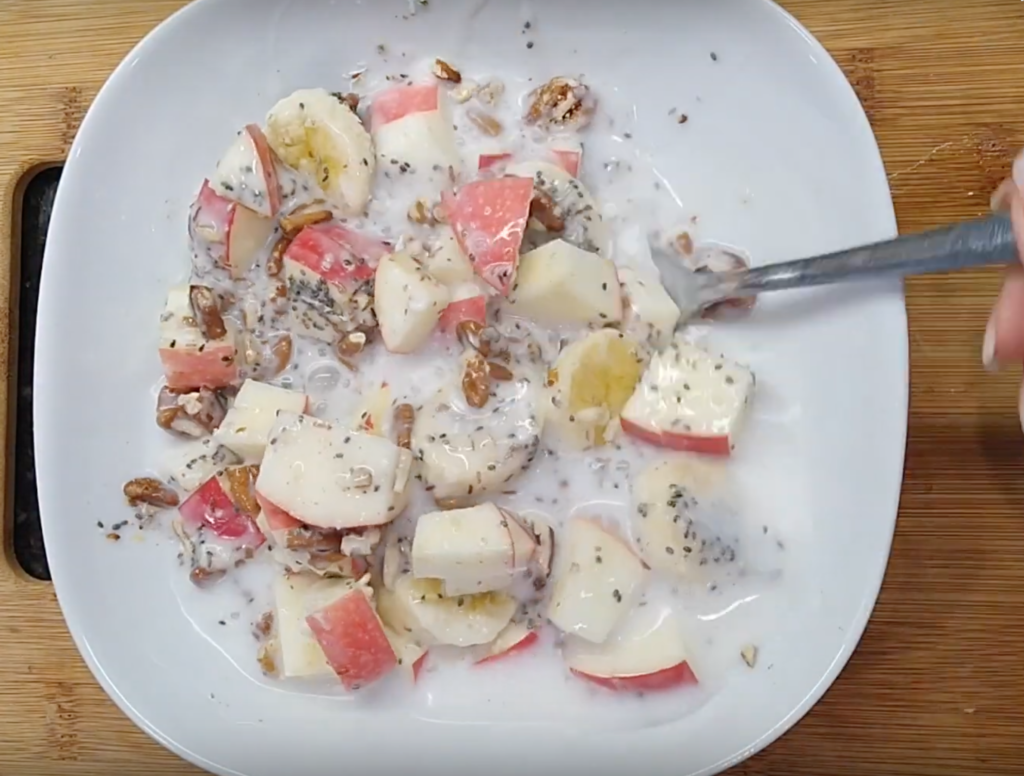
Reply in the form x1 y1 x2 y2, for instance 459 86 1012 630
505 162 611 257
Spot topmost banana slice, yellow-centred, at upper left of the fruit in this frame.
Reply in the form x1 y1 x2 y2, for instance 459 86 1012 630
266 89 376 215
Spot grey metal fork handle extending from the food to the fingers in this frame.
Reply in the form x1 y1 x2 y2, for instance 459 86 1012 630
700 214 1018 304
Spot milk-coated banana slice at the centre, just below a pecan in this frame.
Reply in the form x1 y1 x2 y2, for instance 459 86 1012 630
413 356 543 503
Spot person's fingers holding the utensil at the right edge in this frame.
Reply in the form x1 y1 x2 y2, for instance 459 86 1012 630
981 152 1024 415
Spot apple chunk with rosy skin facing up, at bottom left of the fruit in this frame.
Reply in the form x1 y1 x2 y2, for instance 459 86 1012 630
306 590 397 690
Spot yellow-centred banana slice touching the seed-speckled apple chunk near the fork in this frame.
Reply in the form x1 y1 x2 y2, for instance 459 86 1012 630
543 329 643 450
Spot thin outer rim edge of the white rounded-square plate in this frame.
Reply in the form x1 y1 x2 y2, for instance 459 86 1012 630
33 0 910 776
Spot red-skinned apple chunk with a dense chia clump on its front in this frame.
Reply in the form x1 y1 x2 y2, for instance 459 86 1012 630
284 221 390 342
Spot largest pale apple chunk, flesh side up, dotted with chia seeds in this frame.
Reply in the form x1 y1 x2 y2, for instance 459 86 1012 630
256 413 412 528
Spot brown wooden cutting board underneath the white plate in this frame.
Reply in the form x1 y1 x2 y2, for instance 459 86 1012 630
0 0 1024 776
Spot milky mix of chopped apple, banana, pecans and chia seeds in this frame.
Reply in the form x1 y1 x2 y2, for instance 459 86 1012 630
119 59 778 704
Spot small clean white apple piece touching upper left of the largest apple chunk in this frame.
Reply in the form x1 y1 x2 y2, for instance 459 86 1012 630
214 380 308 462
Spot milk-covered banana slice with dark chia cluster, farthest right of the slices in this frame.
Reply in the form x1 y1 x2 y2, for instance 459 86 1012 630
631 456 737 580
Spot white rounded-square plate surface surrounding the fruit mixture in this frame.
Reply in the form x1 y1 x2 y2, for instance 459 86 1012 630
35 0 907 776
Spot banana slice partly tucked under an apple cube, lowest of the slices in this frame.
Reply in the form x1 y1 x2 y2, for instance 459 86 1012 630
377 574 518 647
